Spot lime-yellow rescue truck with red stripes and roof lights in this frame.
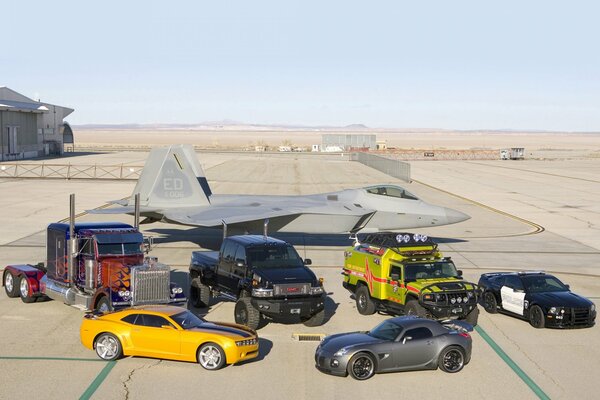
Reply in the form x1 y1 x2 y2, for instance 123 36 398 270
342 233 479 325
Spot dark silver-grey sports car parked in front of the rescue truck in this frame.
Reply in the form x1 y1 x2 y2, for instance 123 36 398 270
315 316 473 380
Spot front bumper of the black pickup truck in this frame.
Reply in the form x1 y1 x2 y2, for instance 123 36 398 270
251 294 326 318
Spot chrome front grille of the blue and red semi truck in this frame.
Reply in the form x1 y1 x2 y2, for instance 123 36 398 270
131 263 171 305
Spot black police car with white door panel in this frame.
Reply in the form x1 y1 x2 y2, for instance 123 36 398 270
479 271 596 328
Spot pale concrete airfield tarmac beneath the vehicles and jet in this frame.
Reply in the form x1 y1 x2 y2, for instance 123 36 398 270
0 152 600 399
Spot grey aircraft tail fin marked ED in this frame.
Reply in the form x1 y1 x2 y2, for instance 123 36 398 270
129 144 212 209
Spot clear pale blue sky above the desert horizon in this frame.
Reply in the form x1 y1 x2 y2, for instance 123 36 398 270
0 0 600 131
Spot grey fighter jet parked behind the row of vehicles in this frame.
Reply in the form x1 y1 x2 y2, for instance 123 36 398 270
90 145 470 234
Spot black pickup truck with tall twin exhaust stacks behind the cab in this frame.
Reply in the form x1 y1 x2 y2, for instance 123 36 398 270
190 235 326 329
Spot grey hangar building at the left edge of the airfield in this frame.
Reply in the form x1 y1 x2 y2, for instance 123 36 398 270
0 87 74 161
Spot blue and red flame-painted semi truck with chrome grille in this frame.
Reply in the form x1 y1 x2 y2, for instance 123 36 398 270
2 195 187 312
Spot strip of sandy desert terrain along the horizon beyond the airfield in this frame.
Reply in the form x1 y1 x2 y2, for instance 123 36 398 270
75 128 600 158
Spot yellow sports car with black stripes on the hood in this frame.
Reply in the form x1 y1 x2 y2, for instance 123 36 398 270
80 306 258 370
